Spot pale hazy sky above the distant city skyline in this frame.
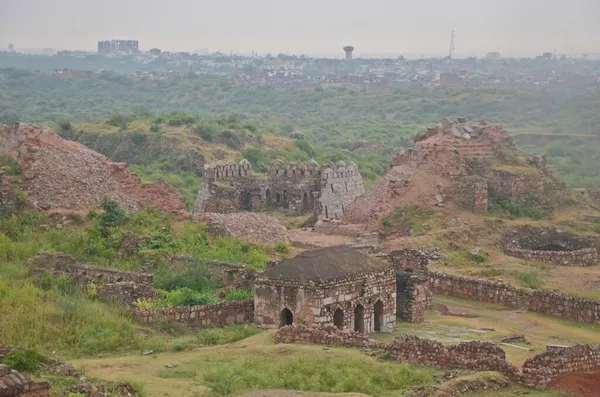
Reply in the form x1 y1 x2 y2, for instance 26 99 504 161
0 0 600 56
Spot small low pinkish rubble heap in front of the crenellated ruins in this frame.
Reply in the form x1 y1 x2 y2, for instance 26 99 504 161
194 212 288 243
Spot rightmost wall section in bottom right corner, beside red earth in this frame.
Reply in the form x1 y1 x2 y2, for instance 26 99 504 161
520 345 600 389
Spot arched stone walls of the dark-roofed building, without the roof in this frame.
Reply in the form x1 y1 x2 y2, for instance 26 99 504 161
255 269 396 333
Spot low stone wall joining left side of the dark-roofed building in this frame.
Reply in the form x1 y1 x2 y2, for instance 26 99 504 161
132 299 254 327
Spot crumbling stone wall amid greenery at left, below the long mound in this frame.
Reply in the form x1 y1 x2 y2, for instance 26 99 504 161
28 253 157 306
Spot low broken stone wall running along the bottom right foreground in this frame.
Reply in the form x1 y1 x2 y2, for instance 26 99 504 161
275 325 600 389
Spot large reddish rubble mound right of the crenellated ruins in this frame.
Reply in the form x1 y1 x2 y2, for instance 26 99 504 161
342 118 558 229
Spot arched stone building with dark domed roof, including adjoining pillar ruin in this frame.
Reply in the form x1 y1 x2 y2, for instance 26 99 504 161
255 246 427 334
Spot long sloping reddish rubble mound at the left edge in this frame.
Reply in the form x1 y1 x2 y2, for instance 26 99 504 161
0 123 185 213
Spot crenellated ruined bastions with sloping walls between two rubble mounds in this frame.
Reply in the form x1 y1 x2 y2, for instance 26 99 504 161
194 159 365 219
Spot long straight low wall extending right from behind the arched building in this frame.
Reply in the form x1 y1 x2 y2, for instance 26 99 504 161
429 272 600 325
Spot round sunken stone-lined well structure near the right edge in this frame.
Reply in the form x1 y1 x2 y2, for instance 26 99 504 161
502 226 598 266
